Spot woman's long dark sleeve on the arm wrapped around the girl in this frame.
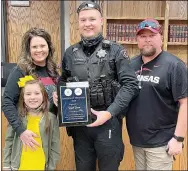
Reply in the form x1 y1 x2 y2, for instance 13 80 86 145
2 67 26 136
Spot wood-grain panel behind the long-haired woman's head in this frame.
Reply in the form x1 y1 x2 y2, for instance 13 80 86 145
7 1 61 63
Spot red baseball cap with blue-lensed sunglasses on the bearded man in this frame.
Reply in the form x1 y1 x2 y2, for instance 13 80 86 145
136 19 161 35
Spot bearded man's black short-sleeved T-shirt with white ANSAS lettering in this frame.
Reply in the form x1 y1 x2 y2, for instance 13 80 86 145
126 51 187 148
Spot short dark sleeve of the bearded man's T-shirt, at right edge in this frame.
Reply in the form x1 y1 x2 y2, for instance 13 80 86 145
171 62 187 101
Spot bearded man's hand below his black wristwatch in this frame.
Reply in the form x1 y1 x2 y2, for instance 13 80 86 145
167 138 183 156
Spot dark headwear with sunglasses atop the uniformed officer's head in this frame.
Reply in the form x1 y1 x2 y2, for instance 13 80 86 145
77 1 102 14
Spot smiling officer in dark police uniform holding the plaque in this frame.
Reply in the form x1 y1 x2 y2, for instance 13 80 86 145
54 2 139 171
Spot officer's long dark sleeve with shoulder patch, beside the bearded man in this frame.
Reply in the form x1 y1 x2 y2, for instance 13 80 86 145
107 46 139 116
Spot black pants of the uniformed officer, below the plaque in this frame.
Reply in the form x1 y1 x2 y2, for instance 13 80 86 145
72 118 124 171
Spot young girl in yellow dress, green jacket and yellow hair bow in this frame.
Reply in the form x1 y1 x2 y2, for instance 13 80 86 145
3 76 60 170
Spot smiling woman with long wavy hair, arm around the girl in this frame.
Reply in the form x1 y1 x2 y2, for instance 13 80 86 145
2 28 59 148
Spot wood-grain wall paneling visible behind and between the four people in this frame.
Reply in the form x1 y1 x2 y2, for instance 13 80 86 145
2 1 187 170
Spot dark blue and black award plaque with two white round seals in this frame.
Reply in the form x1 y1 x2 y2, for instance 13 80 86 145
57 82 91 127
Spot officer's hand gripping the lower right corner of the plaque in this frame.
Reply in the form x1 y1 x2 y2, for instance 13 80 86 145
87 109 112 127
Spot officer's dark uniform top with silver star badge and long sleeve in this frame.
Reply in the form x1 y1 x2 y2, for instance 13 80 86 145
59 41 139 116
